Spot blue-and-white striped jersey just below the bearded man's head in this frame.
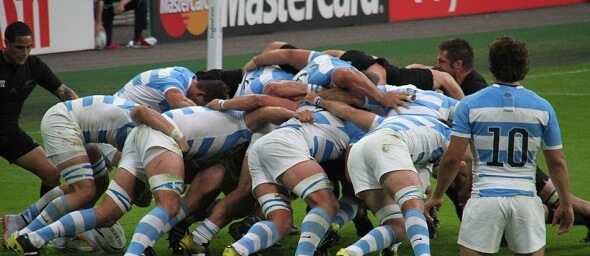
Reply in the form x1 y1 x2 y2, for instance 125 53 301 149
364 85 459 122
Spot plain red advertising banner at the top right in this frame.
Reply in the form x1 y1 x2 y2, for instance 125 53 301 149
389 0 588 21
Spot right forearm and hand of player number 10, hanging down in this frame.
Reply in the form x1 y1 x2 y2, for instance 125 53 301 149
543 149 574 234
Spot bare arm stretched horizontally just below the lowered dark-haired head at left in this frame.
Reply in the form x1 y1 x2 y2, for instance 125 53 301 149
207 94 299 111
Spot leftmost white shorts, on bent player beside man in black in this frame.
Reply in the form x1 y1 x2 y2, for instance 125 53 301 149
41 104 86 164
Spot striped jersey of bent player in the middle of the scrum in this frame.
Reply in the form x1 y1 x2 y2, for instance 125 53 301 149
277 104 365 163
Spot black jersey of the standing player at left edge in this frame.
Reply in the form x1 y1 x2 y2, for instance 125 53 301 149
0 55 62 134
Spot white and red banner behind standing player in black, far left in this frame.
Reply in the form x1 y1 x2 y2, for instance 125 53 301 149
0 0 94 54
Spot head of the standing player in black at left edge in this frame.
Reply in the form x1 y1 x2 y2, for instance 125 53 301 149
3 21 33 65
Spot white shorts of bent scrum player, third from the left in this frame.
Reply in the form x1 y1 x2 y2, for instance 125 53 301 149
248 128 313 189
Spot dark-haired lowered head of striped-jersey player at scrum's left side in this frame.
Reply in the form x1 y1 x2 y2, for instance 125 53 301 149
186 79 229 106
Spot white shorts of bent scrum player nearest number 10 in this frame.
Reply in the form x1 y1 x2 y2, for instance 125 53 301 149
347 129 416 194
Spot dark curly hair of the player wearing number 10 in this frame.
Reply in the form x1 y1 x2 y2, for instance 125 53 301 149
488 36 529 83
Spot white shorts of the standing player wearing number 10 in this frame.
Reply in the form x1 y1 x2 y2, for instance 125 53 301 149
457 196 546 254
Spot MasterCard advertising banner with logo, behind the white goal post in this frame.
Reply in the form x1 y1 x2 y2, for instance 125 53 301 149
150 0 388 41
